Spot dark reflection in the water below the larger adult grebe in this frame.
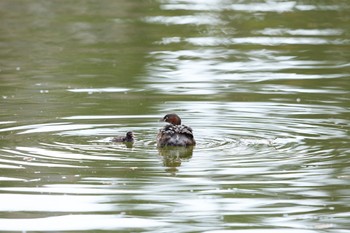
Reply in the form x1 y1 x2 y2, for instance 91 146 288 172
158 146 193 172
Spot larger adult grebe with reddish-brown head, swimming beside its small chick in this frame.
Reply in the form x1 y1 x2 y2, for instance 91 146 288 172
157 113 196 147
